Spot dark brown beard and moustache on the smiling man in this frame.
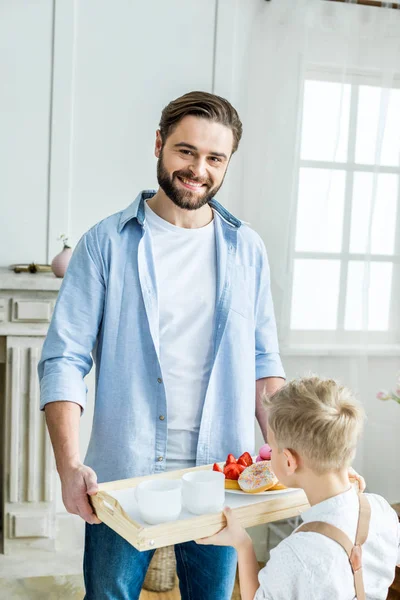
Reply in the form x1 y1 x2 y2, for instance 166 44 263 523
157 151 225 210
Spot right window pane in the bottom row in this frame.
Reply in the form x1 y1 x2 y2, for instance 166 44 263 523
344 261 393 331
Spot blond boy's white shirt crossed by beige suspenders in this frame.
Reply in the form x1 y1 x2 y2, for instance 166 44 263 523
254 489 400 600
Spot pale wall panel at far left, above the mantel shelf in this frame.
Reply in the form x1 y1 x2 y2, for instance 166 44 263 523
0 0 53 266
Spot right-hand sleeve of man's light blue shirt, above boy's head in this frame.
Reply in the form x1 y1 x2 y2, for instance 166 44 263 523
255 244 286 379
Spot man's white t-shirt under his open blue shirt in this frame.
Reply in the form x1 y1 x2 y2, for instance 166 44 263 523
145 202 216 470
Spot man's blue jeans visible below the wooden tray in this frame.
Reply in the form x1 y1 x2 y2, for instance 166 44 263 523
83 523 237 600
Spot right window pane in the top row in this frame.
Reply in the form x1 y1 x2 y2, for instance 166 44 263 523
356 85 400 167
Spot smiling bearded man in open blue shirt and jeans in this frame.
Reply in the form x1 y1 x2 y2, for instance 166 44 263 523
39 92 284 600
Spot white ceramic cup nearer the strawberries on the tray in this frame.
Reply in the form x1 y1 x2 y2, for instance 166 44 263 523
182 471 225 515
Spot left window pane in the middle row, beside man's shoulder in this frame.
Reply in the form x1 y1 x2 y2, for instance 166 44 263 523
295 169 346 252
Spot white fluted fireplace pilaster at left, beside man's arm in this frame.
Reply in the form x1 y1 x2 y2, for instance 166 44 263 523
4 336 55 552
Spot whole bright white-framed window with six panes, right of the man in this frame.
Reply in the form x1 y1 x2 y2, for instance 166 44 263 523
290 73 400 343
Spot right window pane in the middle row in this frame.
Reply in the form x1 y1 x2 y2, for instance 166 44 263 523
350 173 399 254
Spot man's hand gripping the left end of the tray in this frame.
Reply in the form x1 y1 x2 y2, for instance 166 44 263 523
60 464 101 525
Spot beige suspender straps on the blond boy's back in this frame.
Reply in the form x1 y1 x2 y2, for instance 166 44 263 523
295 494 371 600
